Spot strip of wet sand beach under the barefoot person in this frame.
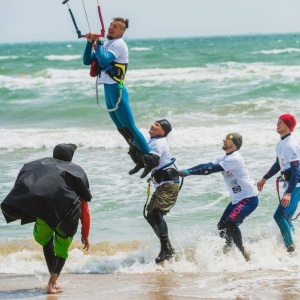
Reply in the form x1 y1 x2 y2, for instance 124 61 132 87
0 271 300 300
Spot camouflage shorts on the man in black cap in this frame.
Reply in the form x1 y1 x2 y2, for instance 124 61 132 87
147 182 179 214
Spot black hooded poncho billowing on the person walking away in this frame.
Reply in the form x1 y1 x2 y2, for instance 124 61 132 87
1 144 92 237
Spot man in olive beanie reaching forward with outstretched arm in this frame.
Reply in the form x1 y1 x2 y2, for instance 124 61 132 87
179 132 258 261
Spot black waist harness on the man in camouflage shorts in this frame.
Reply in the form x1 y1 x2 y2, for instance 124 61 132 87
143 158 183 219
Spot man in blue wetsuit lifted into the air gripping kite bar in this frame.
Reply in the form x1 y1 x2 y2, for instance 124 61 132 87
83 18 149 176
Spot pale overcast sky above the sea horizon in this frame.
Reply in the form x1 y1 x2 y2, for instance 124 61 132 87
0 0 300 43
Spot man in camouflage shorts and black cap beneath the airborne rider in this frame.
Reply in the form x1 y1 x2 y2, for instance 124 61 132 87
127 119 179 263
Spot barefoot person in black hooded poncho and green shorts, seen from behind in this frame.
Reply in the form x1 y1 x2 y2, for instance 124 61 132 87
1 144 92 294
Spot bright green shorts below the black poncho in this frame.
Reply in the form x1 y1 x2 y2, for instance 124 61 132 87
33 218 73 258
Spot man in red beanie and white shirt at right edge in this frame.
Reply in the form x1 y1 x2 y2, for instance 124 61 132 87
257 114 300 252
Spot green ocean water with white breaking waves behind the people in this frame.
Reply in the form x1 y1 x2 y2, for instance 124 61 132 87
0 34 300 288
